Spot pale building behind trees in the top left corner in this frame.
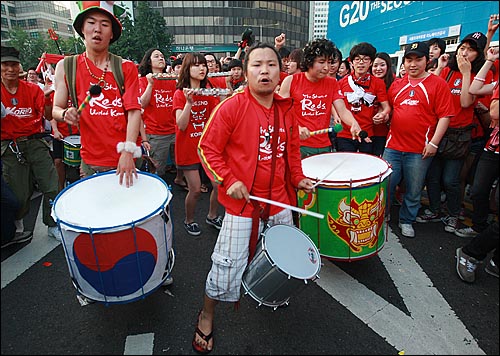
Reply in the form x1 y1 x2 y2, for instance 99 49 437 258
1 1 74 44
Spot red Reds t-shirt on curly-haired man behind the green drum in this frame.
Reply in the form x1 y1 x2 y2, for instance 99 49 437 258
290 72 344 148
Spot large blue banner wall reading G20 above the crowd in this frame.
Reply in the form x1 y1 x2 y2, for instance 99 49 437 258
327 1 498 61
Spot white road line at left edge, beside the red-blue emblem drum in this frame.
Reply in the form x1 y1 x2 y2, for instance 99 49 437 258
2 199 61 289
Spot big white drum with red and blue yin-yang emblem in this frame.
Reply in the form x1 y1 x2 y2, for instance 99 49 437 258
52 171 174 304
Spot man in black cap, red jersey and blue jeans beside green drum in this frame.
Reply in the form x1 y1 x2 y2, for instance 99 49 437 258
383 42 454 238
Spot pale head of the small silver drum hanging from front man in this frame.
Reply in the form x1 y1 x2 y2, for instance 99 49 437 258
264 225 321 279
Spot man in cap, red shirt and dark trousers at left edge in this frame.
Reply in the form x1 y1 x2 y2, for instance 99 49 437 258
1 46 61 243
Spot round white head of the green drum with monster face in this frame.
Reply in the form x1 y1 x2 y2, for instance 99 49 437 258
302 152 392 187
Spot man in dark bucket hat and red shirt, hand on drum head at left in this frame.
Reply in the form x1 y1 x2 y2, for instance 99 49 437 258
52 1 142 187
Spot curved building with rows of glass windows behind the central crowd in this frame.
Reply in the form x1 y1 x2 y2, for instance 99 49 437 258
141 0 313 53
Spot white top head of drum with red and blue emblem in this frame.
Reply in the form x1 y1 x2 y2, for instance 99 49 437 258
52 171 172 229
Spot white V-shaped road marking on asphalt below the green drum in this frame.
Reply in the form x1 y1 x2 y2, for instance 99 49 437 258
316 230 485 355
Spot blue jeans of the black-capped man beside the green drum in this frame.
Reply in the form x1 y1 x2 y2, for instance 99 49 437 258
383 148 432 224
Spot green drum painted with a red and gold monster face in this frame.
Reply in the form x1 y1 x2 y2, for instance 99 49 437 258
298 152 392 261
